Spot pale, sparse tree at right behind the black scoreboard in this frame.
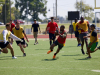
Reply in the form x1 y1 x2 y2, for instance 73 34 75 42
75 1 94 20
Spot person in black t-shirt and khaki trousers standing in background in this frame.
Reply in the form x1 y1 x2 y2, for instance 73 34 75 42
31 19 41 45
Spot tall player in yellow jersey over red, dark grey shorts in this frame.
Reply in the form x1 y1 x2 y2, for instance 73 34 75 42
77 17 90 54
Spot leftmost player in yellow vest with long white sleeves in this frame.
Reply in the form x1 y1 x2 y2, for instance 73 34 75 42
0 23 23 59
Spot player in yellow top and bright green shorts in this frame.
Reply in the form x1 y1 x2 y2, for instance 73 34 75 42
84 24 99 58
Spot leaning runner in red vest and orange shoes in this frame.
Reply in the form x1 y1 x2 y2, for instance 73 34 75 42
47 25 67 59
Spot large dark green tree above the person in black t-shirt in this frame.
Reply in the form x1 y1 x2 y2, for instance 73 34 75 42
15 0 47 20
